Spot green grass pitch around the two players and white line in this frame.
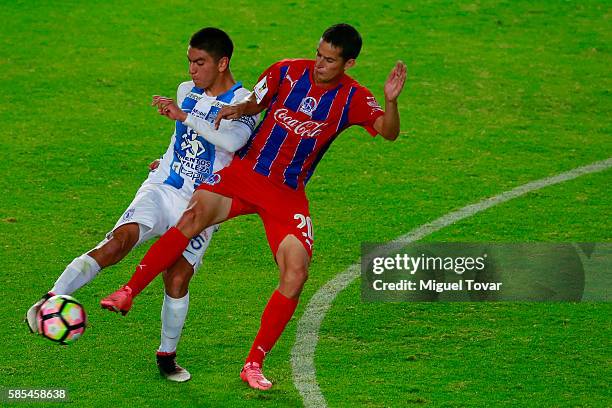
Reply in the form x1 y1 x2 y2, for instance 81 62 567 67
0 0 612 407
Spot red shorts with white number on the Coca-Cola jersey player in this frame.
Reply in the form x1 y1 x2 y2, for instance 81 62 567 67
197 158 314 258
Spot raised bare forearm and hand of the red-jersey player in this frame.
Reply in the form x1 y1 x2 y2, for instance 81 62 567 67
374 61 406 140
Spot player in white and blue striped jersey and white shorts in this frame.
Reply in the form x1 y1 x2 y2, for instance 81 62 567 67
26 27 258 381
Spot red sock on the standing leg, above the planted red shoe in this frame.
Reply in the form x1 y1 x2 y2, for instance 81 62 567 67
246 290 298 366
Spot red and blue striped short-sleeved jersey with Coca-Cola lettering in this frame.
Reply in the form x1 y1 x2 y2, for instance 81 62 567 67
238 60 384 190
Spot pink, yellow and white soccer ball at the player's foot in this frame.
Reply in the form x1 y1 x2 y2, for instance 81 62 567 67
37 295 87 344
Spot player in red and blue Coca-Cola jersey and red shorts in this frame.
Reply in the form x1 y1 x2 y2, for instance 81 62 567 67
102 24 406 390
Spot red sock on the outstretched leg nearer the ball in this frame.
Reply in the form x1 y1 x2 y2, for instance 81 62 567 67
126 227 189 297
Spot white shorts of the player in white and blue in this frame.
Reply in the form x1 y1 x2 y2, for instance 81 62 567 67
98 182 213 272
